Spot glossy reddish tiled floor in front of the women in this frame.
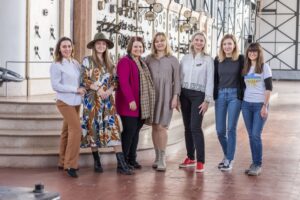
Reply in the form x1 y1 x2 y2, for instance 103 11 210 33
0 82 300 200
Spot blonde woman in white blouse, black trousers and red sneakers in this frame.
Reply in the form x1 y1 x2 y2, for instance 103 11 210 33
179 32 214 172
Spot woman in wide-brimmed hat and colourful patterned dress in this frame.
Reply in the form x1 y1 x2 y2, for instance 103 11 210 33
80 32 133 175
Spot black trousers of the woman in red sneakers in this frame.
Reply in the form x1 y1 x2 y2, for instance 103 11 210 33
180 88 205 163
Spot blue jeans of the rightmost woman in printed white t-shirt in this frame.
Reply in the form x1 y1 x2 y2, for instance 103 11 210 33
242 101 267 166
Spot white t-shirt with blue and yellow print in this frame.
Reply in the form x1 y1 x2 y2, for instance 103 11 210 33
244 63 272 103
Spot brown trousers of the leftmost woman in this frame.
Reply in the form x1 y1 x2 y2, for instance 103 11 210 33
56 100 81 169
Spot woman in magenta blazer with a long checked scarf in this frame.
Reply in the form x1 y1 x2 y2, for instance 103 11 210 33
116 37 155 169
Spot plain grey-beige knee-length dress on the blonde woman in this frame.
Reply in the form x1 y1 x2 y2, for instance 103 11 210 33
146 55 180 127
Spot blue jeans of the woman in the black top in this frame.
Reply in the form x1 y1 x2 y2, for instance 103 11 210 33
215 88 241 161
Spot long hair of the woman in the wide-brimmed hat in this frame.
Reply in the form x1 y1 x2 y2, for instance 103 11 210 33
92 41 115 74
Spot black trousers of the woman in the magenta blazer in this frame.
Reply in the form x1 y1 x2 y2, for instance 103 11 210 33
121 116 144 163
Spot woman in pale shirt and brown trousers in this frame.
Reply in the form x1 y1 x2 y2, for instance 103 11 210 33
50 37 86 178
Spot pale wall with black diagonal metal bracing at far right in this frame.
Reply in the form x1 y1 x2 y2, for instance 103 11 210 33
255 0 300 80
